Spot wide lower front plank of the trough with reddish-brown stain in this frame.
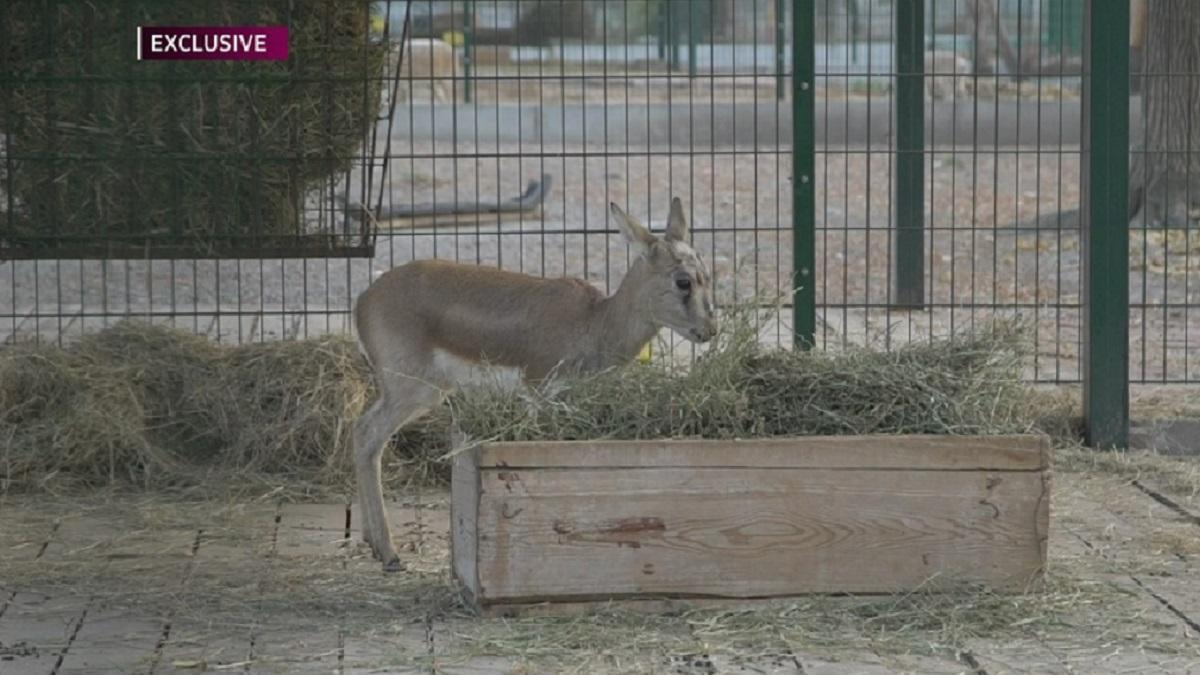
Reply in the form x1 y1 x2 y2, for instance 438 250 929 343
476 468 1048 602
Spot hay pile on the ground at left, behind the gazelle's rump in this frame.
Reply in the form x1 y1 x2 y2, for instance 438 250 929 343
0 322 371 489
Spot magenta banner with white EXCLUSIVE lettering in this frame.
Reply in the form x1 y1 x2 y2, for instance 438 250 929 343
138 25 288 61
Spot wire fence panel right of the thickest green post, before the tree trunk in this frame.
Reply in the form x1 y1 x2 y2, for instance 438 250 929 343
1129 0 1200 383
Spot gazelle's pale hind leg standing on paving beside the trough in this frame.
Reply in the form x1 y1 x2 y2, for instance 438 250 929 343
354 374 443 572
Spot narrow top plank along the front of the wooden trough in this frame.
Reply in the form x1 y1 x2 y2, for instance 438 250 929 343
479 435 1050 471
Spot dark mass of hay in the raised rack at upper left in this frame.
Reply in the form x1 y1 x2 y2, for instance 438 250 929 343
0 0 386 241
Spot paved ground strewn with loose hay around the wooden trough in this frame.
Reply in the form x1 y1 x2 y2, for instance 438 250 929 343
0 460 1200 675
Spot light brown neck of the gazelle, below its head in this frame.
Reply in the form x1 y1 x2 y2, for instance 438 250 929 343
592 258 661 365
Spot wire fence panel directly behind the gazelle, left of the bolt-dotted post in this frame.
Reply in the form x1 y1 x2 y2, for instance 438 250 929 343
377 0 791 355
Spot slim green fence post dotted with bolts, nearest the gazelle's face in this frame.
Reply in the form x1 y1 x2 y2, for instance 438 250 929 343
792 0 817 350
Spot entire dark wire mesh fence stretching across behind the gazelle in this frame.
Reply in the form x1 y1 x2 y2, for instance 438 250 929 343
0 0 1200 382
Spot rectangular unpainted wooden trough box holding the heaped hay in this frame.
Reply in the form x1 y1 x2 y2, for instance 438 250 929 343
451 436 1050 610
